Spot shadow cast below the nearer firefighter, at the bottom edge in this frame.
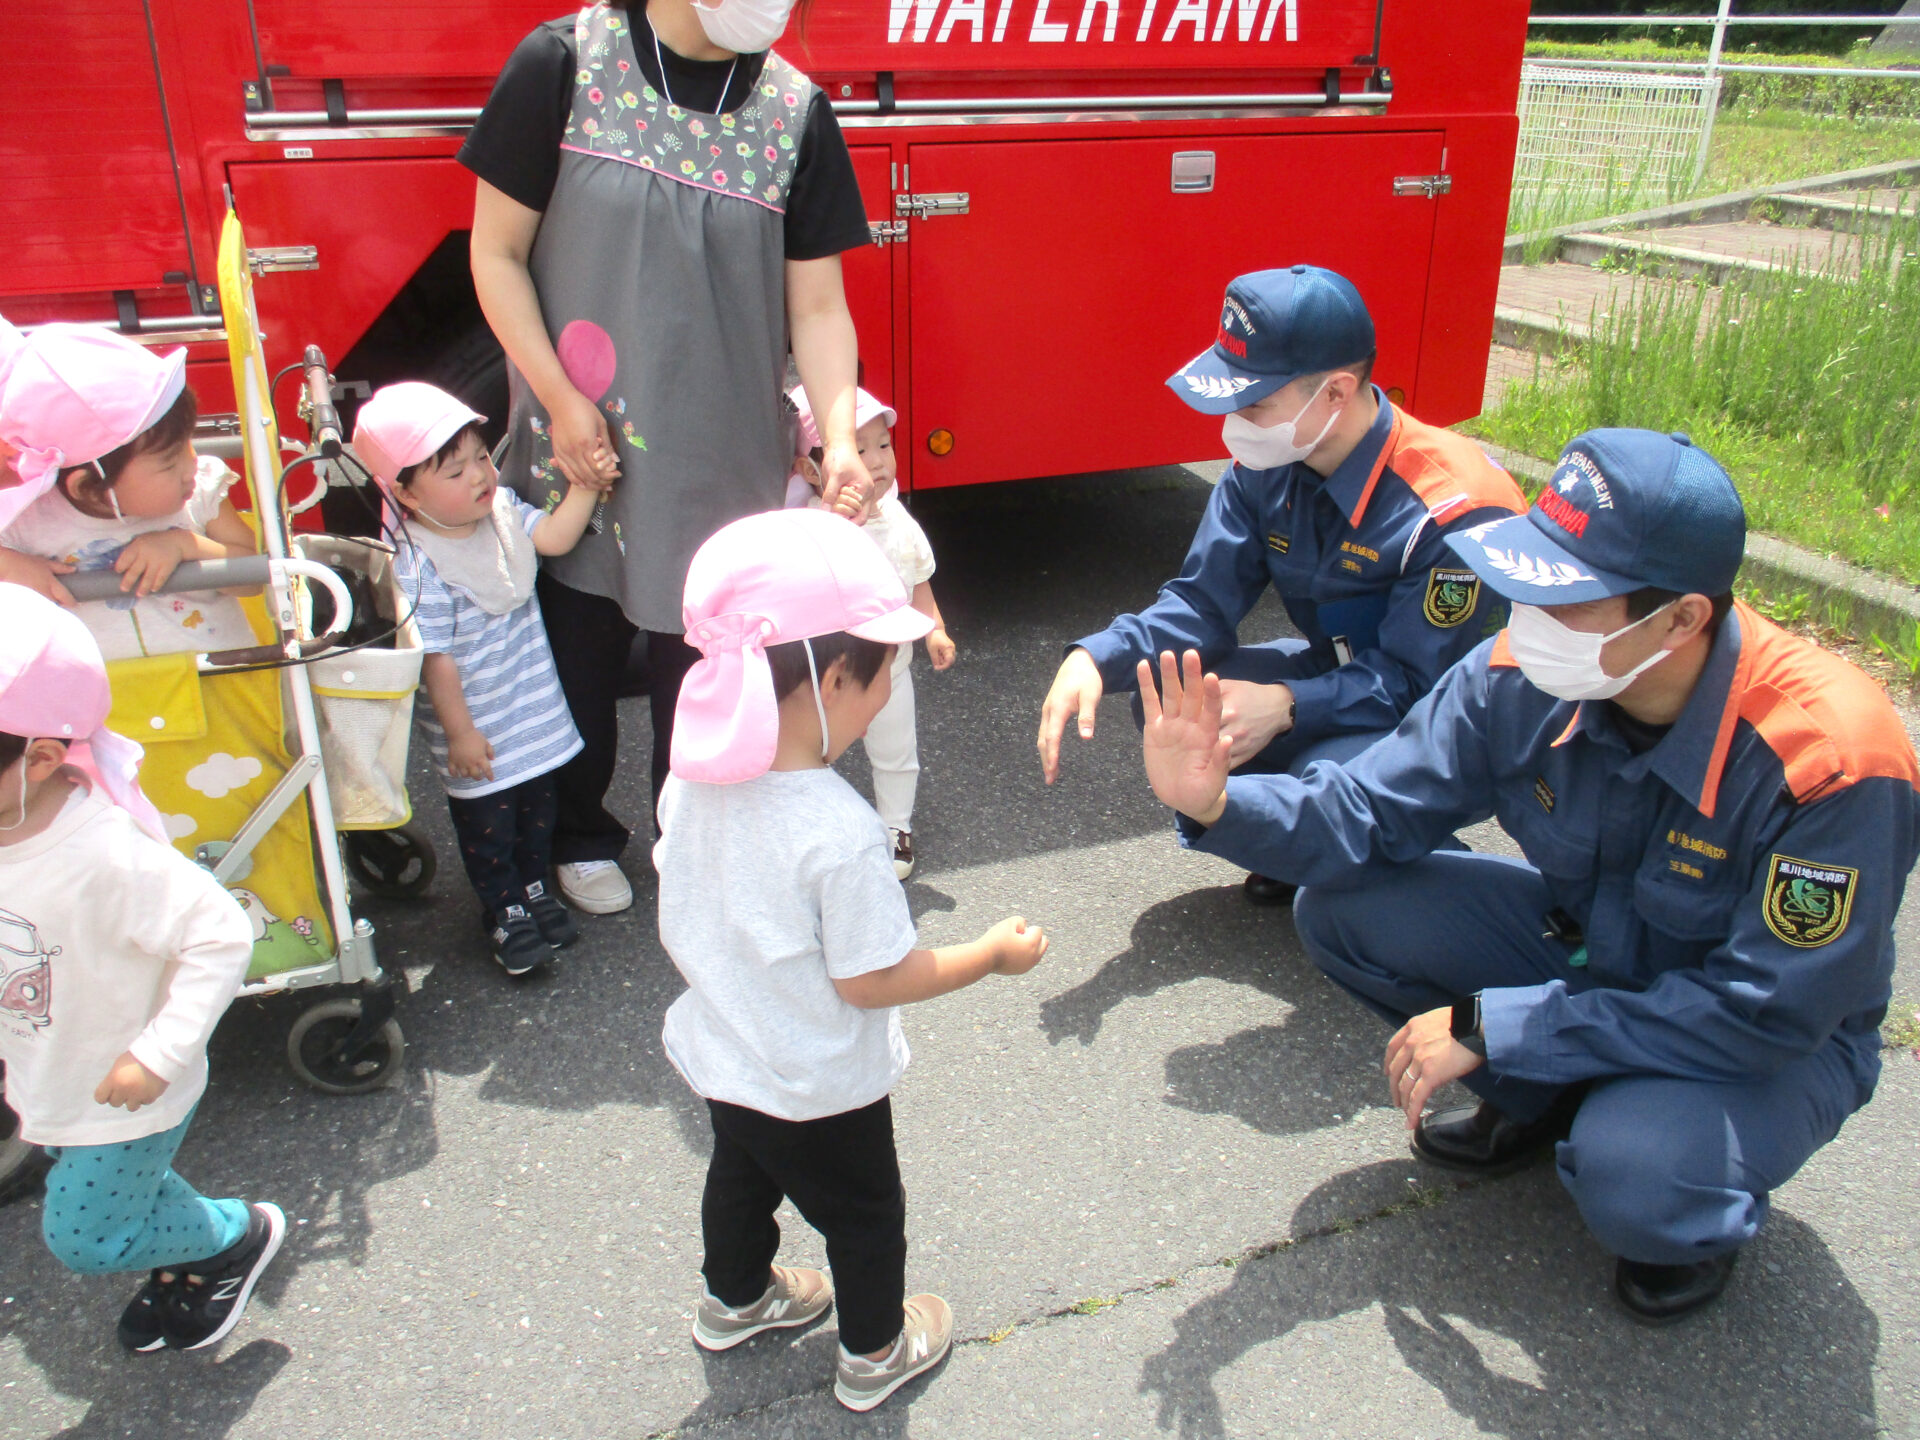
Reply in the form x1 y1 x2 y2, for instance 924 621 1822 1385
1140 1162 1880 1440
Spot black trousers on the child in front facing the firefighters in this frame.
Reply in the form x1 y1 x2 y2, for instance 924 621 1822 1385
701 1096 906 1356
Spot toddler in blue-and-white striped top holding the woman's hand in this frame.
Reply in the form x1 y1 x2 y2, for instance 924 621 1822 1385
353 380 599 975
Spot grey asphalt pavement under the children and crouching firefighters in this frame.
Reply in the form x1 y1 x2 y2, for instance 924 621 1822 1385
0 470 1920 1440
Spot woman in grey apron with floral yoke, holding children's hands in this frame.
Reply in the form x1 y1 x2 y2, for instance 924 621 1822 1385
459 0 870 914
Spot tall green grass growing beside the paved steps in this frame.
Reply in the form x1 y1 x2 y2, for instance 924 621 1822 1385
1476 221 1920 579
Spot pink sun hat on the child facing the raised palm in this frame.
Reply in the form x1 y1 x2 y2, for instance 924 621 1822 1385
670 511 933 785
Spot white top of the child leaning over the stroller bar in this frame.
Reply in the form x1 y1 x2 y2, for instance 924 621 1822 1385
0 455 259 660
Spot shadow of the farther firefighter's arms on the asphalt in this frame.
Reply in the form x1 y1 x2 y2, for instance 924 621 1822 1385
1041 885 1386 1135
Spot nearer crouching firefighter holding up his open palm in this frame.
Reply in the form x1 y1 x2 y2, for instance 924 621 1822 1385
1144 430 1920 1321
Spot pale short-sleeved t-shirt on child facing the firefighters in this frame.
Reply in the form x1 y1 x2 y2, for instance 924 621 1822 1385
653 768 918 1119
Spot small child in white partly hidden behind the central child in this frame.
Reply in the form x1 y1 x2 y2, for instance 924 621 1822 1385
787 386 958 879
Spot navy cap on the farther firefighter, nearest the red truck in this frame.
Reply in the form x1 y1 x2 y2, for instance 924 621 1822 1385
1167 265 1375 415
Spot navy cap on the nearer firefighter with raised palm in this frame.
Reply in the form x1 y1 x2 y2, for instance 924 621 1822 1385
1446 430 1747 605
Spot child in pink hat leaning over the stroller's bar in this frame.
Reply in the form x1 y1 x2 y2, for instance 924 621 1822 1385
0 324 255 660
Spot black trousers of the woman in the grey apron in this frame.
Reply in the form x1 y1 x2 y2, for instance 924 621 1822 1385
540 572 701 864
